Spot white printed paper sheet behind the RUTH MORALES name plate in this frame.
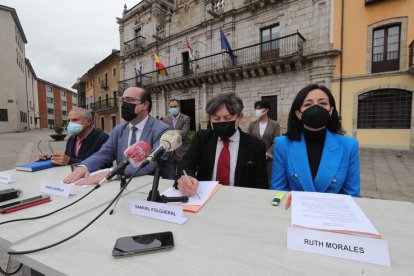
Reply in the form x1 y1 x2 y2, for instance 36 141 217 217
291 192 380 237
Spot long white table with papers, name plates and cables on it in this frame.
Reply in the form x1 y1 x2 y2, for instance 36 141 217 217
0 167 414 275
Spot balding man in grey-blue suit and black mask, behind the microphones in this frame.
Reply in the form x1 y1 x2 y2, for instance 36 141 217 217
63 87 175 185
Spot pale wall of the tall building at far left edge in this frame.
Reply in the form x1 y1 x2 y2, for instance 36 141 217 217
0 9 28 132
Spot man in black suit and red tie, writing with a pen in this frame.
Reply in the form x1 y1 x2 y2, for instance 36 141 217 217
176 93 268 195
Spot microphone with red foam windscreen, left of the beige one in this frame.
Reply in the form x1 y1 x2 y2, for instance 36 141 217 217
98 141 152 185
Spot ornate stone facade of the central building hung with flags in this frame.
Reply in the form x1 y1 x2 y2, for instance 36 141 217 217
120 0 333 129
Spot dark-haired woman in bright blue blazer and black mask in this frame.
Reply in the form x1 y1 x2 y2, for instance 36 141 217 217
272 84 360 197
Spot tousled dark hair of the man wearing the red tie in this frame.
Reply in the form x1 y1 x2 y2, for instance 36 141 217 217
206 92 244 116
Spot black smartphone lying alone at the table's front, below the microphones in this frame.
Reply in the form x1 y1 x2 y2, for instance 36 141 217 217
112 232 174 257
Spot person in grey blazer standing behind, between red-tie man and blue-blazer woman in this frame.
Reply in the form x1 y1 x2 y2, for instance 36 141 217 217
247 101 280 188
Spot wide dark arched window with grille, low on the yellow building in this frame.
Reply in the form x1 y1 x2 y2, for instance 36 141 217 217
357 89 413 129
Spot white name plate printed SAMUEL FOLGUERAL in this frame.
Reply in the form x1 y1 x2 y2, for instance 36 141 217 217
130 200 187 224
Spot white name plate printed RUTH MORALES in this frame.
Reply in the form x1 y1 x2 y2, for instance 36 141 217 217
287 227 391 266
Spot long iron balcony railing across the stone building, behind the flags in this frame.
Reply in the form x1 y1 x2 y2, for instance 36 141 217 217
119 32 305 91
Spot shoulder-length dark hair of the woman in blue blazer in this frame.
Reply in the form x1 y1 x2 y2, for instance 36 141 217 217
286 84 345 141
